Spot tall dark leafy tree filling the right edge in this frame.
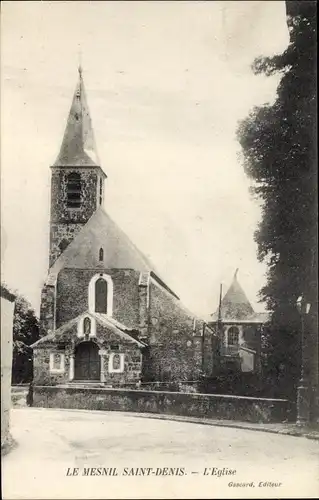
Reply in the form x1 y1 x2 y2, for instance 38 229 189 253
237 1 318 397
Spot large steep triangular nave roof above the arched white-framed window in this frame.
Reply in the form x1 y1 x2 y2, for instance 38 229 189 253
46 207 178 298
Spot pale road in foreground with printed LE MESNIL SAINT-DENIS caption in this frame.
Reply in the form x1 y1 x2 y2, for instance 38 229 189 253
2 408 319 500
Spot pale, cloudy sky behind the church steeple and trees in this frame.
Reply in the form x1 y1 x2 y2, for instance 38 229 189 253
1 0 288 316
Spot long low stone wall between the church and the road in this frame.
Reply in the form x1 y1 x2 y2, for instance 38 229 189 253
33 386 289 423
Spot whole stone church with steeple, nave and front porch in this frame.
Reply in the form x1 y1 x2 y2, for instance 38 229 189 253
33 68 217 388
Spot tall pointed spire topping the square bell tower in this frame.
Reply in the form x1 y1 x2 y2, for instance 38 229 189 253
53 66 100 167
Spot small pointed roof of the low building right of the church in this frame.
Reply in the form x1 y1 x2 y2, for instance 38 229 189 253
212 269 255 321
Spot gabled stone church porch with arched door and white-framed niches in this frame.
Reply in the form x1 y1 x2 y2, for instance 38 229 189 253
33 313 145 387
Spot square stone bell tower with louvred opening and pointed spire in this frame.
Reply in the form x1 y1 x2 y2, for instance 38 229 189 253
49 67 107 267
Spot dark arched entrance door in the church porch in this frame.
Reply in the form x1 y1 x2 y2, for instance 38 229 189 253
74 342 100 380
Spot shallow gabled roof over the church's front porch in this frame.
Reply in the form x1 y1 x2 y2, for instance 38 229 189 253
30 311 146 349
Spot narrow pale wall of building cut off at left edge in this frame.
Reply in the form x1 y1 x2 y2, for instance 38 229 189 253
1 289 15 450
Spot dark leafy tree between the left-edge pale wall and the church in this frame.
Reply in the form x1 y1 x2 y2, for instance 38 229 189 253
2 284 39 384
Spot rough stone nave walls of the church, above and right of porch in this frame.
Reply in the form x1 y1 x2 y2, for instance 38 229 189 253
41 268 218 383
